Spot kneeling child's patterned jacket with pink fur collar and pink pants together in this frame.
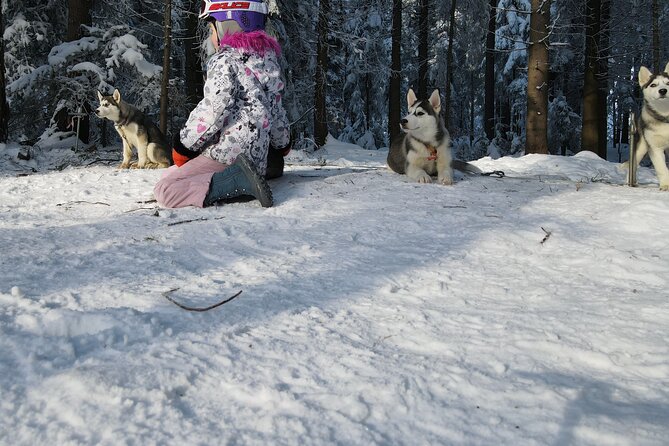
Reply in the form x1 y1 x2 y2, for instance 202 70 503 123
153 31 290 208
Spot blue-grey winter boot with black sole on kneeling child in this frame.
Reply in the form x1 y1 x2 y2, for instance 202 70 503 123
204 154 274 208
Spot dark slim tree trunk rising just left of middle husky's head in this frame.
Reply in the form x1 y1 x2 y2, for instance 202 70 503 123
388 0 402 144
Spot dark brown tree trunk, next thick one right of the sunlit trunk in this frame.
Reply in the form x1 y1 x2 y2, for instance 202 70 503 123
581 0 606 153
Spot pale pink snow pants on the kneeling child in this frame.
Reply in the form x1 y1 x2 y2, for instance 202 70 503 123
153 155 228 208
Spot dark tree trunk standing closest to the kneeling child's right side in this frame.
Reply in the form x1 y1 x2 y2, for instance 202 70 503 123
314 0 330 148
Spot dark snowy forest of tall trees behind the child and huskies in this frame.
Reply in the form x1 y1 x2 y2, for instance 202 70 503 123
0 0 669 161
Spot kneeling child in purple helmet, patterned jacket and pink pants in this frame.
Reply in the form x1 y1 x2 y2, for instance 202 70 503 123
154 0 291 208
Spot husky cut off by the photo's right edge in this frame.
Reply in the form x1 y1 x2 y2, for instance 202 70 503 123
634 63 669 191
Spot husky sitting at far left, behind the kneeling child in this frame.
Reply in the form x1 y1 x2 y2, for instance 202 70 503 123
95 90 172 169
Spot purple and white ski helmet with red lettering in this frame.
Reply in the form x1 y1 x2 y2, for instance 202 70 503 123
198 0 268 33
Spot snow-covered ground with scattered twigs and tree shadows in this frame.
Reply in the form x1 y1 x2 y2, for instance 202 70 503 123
0 139 669 445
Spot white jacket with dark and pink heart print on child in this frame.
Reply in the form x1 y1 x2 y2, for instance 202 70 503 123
180 37 290 175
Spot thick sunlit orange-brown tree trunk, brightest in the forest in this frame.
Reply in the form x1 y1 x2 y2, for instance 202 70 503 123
525 0 550 153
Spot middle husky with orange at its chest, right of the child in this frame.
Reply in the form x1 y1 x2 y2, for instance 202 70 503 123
387 89 481 185
